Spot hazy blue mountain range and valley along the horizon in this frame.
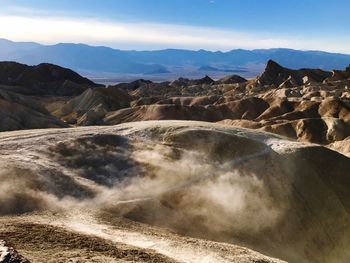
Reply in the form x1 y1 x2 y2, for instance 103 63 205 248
0 39 350 83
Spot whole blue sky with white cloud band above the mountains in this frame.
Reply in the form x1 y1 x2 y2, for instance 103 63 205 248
0 0 350 54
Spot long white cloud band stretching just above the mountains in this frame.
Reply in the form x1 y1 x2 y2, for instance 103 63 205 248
0 15 350 53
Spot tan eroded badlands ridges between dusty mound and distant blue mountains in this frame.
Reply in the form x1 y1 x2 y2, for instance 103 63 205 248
30 61 350 154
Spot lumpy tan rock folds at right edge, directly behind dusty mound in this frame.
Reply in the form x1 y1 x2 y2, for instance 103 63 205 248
222 98 350 144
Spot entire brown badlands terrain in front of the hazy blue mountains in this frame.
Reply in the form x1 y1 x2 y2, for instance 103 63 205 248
0 61 350 263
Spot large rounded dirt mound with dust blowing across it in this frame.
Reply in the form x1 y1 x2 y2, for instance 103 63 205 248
0 121 350 262
